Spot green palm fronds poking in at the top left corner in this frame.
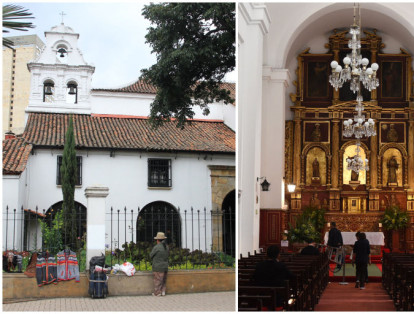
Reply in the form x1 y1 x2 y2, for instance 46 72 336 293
3 4 35 48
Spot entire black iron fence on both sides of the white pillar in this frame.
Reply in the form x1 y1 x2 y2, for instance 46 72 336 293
3 202 235 270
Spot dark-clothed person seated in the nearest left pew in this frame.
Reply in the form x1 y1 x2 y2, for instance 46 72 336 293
253 245 295 307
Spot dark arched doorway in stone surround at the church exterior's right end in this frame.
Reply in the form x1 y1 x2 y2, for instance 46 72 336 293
221 190 236 257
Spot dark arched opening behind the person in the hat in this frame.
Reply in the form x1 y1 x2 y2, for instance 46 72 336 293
136 201 181 247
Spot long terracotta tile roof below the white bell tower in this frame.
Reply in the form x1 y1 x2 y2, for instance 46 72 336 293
23 113 235 154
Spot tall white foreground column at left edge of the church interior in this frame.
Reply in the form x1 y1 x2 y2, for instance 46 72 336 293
237 3 270 256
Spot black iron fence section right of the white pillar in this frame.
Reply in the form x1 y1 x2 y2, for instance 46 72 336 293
106 202 235 270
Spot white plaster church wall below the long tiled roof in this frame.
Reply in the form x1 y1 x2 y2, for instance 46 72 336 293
24 149 235 249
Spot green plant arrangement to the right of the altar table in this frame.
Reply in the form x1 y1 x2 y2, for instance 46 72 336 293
380 205 408 252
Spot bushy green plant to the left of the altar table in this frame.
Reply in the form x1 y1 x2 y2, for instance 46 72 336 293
286 207 325 252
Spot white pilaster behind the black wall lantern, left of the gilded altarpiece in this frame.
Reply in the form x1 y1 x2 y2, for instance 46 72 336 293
260 66 290 209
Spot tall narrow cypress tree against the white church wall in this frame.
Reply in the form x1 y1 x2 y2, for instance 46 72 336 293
60 116 77 249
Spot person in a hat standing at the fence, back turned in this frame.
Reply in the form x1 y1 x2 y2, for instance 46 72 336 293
150 232 168 297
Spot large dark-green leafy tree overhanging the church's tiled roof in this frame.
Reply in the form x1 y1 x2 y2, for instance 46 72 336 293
141 3 236 127
